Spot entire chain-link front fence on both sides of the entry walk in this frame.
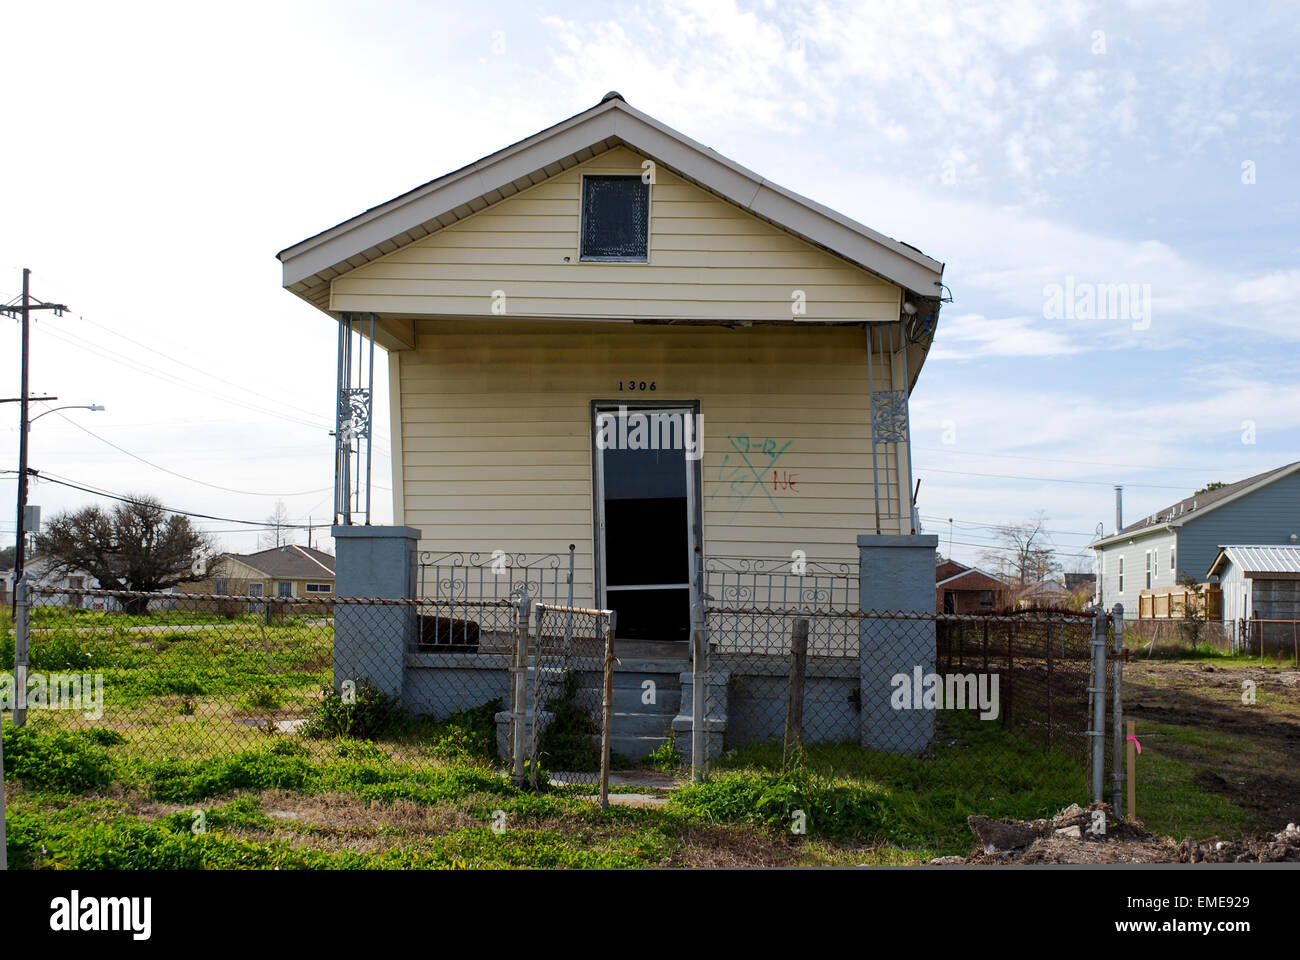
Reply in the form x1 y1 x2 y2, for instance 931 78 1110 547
0 584 1118 816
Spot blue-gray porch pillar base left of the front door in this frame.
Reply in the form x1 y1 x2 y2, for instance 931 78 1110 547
332 524 420 697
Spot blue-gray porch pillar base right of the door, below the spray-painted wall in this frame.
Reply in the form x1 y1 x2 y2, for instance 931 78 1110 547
858 533 939 756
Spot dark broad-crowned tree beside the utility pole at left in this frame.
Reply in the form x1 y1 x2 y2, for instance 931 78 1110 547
36 497 216 613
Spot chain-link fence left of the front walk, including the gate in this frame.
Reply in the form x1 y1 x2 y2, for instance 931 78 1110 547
0 587 614 801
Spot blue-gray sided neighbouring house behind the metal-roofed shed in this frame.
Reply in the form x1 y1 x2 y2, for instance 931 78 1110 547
1092 460 1300 618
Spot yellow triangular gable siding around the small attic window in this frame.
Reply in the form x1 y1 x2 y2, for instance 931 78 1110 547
330 147 901 320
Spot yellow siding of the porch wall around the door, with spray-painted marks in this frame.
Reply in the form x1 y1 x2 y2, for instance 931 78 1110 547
395 320 907 604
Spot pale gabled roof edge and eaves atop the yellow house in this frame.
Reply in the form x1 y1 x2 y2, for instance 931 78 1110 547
277 95 944 325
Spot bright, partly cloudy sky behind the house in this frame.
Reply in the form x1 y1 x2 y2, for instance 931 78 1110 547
0 0 1300 565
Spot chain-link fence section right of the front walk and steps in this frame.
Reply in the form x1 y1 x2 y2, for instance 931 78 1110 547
696 606 1113 800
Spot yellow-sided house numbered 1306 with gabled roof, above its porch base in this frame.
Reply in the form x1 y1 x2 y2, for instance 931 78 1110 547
278 92 944 640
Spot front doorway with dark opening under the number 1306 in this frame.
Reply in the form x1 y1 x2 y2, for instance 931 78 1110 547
594 407 696 641
